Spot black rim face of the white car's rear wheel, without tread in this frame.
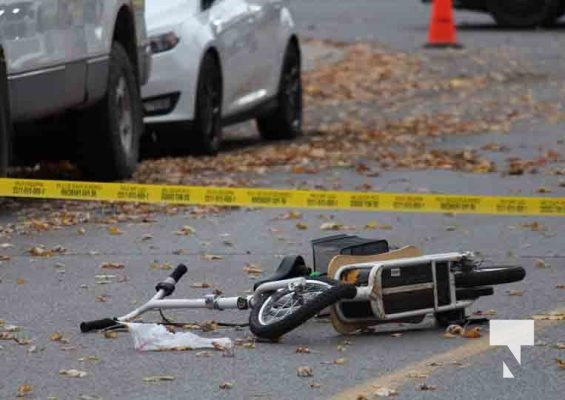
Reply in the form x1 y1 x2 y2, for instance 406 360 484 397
282 54 302 130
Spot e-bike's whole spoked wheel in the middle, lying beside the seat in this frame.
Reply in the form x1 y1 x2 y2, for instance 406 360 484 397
249 280 357 340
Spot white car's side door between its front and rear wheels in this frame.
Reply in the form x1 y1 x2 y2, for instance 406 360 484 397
208 0 258 116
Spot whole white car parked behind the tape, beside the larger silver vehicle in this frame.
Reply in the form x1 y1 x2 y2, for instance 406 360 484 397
142 0 302 155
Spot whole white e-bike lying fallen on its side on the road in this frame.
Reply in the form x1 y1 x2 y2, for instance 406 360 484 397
80 235 526 339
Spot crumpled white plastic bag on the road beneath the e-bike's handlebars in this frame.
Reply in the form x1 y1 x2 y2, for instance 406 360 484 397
125 323 233 351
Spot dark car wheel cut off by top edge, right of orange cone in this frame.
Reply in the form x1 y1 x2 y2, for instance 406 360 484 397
488 0 560 28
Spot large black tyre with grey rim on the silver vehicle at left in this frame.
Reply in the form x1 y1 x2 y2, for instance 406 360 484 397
77 42 143 180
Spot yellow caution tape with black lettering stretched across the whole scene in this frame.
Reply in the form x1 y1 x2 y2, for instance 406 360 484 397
0 178 565 217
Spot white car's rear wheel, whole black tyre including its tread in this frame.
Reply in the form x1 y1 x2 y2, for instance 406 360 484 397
257 43 302 140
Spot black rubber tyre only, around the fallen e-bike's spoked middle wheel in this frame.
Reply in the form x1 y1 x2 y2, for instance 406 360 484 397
249 285 357 340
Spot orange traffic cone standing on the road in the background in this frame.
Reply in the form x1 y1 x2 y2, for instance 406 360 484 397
426 0 462 48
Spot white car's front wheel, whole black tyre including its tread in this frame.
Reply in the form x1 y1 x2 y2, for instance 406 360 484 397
189 53 222 155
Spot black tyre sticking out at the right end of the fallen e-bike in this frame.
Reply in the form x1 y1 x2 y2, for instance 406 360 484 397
455 266 526 288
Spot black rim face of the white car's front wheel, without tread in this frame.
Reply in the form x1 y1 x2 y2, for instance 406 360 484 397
199 65 222 149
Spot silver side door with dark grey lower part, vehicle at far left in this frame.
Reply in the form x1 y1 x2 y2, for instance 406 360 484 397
0 0 85 121
